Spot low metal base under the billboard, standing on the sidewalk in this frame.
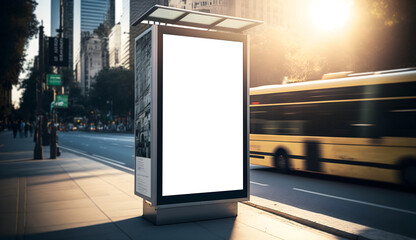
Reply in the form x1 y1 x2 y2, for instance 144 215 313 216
143 200 238 225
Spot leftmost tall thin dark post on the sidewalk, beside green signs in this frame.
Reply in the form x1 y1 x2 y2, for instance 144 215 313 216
33 25 45 160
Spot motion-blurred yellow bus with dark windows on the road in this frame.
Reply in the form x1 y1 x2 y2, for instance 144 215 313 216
250 69 416 186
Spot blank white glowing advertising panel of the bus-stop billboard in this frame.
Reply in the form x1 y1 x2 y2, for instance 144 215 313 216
162 34 244 196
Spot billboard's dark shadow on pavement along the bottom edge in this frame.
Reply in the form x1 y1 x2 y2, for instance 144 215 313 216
24 217 235 240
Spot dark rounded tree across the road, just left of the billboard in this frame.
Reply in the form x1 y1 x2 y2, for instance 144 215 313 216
90 68 134 122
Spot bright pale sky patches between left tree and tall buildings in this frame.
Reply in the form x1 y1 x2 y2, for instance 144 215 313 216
12 0 123 107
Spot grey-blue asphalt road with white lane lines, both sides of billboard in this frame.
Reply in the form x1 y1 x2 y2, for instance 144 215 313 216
59 132 416 238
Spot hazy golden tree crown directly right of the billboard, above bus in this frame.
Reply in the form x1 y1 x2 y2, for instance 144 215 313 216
250 26 327 87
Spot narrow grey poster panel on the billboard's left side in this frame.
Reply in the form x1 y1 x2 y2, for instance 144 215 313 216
134 31 152 199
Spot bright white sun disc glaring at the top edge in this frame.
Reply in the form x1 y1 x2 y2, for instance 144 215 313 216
310 0 352 31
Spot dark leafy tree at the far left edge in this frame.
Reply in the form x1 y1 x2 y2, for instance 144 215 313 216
0 0 38 117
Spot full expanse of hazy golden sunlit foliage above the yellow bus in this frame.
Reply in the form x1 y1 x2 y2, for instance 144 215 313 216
250 0 416 87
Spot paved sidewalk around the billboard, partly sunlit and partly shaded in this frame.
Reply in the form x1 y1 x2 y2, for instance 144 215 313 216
0 131 341 240
